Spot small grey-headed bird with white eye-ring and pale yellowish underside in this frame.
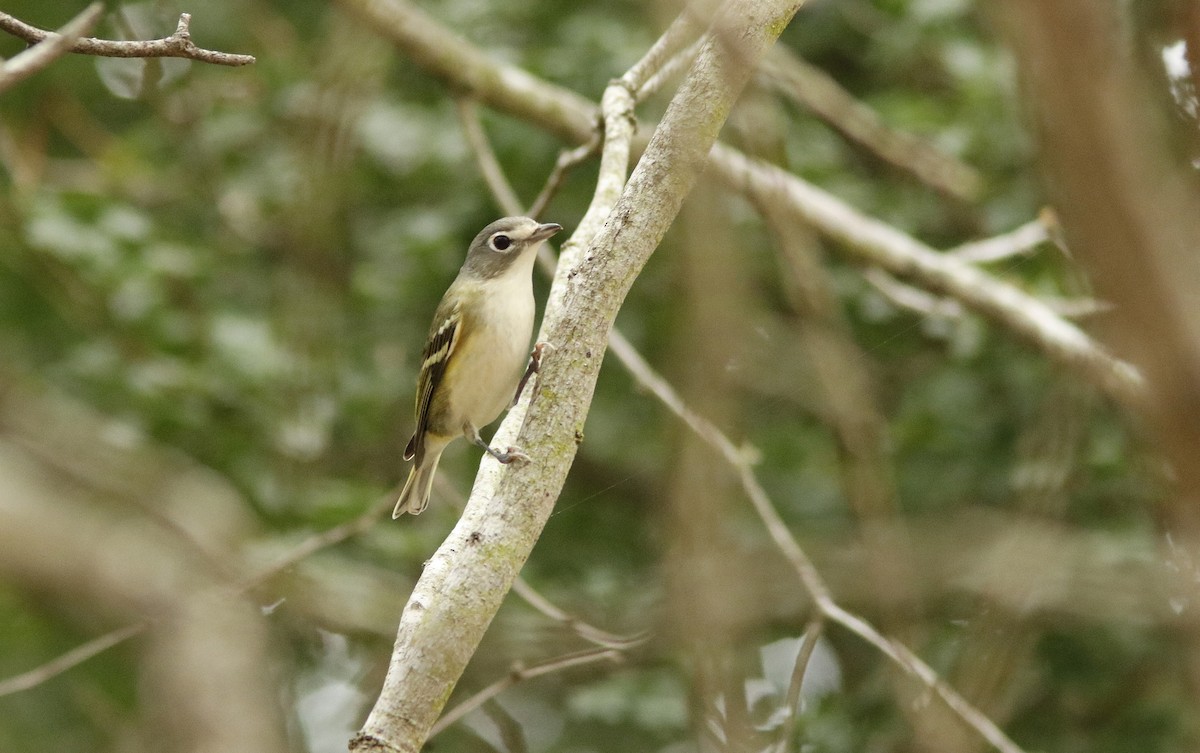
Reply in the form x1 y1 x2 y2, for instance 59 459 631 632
391 217 563 518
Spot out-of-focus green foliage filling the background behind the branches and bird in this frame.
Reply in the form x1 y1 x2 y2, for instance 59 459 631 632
0 0 1200 753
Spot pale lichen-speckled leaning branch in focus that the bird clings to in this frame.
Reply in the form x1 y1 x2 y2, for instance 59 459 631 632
350 0 800 752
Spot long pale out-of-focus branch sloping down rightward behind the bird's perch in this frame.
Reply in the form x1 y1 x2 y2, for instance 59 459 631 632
338 0 1144 412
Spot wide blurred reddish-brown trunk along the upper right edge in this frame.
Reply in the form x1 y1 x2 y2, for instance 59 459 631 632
1002 0 1200 546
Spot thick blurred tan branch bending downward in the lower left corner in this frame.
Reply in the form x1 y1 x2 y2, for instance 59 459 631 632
0 390 286 753
